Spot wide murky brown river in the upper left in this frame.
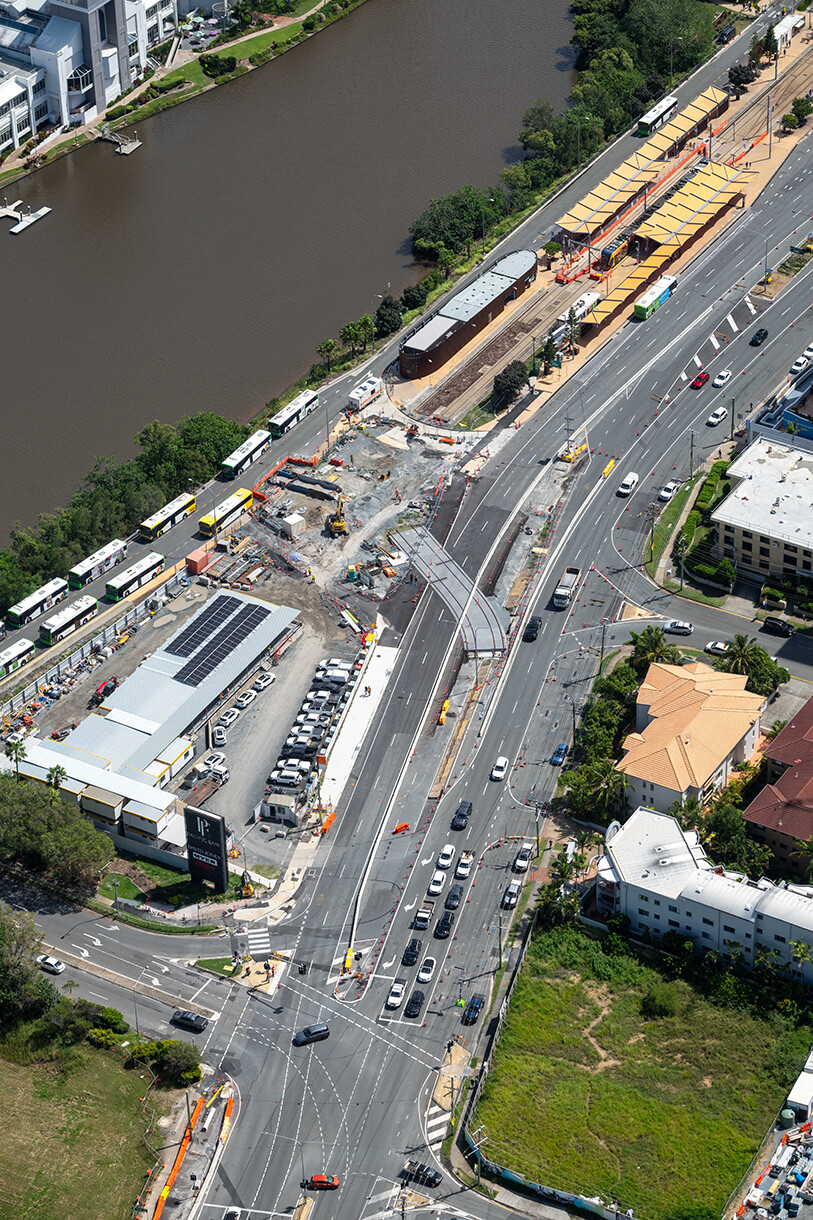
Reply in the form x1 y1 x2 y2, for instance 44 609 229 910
0 0 573 538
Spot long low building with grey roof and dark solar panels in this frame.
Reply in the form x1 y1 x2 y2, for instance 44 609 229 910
0 593 299 865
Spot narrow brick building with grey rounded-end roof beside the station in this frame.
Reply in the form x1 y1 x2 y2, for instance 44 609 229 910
398 250 536 378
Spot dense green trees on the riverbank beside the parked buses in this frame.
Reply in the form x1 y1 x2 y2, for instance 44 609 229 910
0 412 248 612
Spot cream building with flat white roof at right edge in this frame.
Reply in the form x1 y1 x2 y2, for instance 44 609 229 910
712 436 813 580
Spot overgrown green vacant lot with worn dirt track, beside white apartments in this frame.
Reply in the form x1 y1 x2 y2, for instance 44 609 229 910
471 928 813 1220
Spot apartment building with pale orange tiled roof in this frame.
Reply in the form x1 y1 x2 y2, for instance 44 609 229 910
615 661 765 813
